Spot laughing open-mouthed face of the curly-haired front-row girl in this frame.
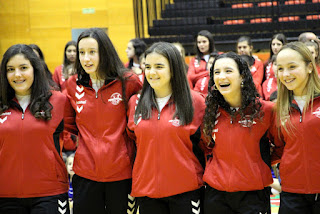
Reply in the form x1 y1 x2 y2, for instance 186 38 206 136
213 58 242 104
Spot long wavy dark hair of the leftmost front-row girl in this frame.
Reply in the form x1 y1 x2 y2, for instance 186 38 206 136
0 44 52 120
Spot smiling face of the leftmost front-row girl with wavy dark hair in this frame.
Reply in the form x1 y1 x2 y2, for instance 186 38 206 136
6 54 34 96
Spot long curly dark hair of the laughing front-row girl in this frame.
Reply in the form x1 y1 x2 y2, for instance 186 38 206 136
203 52 262 139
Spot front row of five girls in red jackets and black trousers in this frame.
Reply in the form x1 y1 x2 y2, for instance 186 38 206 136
0 29 320 214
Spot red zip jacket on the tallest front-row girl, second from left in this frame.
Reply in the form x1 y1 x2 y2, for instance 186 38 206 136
65 73 141 182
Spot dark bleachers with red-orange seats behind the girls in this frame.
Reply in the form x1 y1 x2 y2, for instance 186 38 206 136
139 0 320 54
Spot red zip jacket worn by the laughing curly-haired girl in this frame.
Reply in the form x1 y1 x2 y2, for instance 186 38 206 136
203 101 273 192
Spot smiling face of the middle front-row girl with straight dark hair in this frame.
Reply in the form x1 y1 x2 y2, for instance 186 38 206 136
145 53 172 98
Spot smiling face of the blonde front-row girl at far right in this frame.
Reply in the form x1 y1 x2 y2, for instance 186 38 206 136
277 48 312 96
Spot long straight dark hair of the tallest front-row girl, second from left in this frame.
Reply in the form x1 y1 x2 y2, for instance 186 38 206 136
75 28 127 108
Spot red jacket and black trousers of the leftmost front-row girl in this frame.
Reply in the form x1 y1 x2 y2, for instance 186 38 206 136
0 91 69 214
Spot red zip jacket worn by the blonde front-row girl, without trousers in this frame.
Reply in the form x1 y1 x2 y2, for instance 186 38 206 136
275 96 320 194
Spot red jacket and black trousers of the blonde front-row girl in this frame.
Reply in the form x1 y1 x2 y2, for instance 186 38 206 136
275 96 320 214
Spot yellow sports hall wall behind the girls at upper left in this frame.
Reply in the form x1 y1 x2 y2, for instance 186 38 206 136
0 0 135 72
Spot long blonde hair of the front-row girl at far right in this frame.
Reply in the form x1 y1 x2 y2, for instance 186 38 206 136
276 42 320 132
